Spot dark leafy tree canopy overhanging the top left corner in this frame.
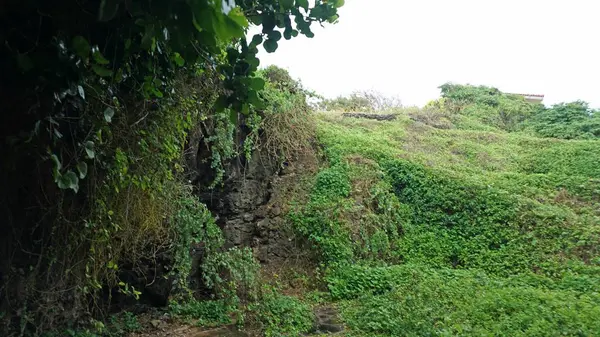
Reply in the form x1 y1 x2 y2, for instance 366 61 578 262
0 0 344 115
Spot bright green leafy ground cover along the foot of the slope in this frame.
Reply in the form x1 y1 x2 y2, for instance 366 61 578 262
330 264 600 336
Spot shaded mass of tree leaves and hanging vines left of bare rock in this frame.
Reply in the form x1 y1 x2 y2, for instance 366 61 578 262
0 0 344 328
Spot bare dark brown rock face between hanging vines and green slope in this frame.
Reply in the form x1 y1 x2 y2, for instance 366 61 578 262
199 147 307 263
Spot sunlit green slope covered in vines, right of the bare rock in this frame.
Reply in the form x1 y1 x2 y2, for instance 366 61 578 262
302 113 600 336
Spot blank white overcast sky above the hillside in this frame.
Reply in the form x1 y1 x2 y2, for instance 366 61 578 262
255 0 600 108
